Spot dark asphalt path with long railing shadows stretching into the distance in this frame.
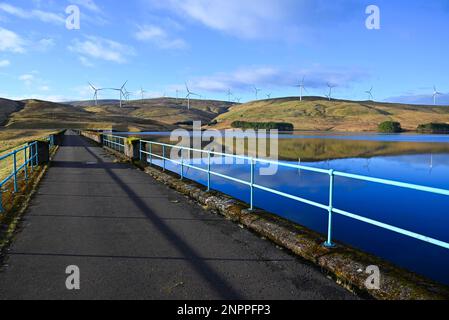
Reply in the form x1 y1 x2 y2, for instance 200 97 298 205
0 132 356 300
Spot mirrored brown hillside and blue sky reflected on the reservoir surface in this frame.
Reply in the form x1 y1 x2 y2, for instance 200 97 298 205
124 131 449 285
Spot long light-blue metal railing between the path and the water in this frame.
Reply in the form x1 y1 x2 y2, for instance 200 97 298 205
138 138 449 249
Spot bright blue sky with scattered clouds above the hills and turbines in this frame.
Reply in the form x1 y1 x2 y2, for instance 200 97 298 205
0 0 449 105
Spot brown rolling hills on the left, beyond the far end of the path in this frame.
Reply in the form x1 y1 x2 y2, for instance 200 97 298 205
0 98 231 131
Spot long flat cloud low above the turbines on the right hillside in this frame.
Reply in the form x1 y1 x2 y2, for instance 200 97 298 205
183 66 368 92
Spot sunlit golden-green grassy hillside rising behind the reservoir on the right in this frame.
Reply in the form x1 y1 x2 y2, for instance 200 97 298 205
215 97 449 131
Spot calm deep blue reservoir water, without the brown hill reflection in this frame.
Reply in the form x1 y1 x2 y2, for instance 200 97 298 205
129 133 449 285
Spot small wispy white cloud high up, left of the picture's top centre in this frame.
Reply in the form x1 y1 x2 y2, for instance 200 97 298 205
134 25 187 49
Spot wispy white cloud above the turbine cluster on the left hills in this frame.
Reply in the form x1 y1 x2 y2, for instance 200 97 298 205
69 36 135 63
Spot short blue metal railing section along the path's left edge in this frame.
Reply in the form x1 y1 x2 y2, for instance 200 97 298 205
0 142 39 213
